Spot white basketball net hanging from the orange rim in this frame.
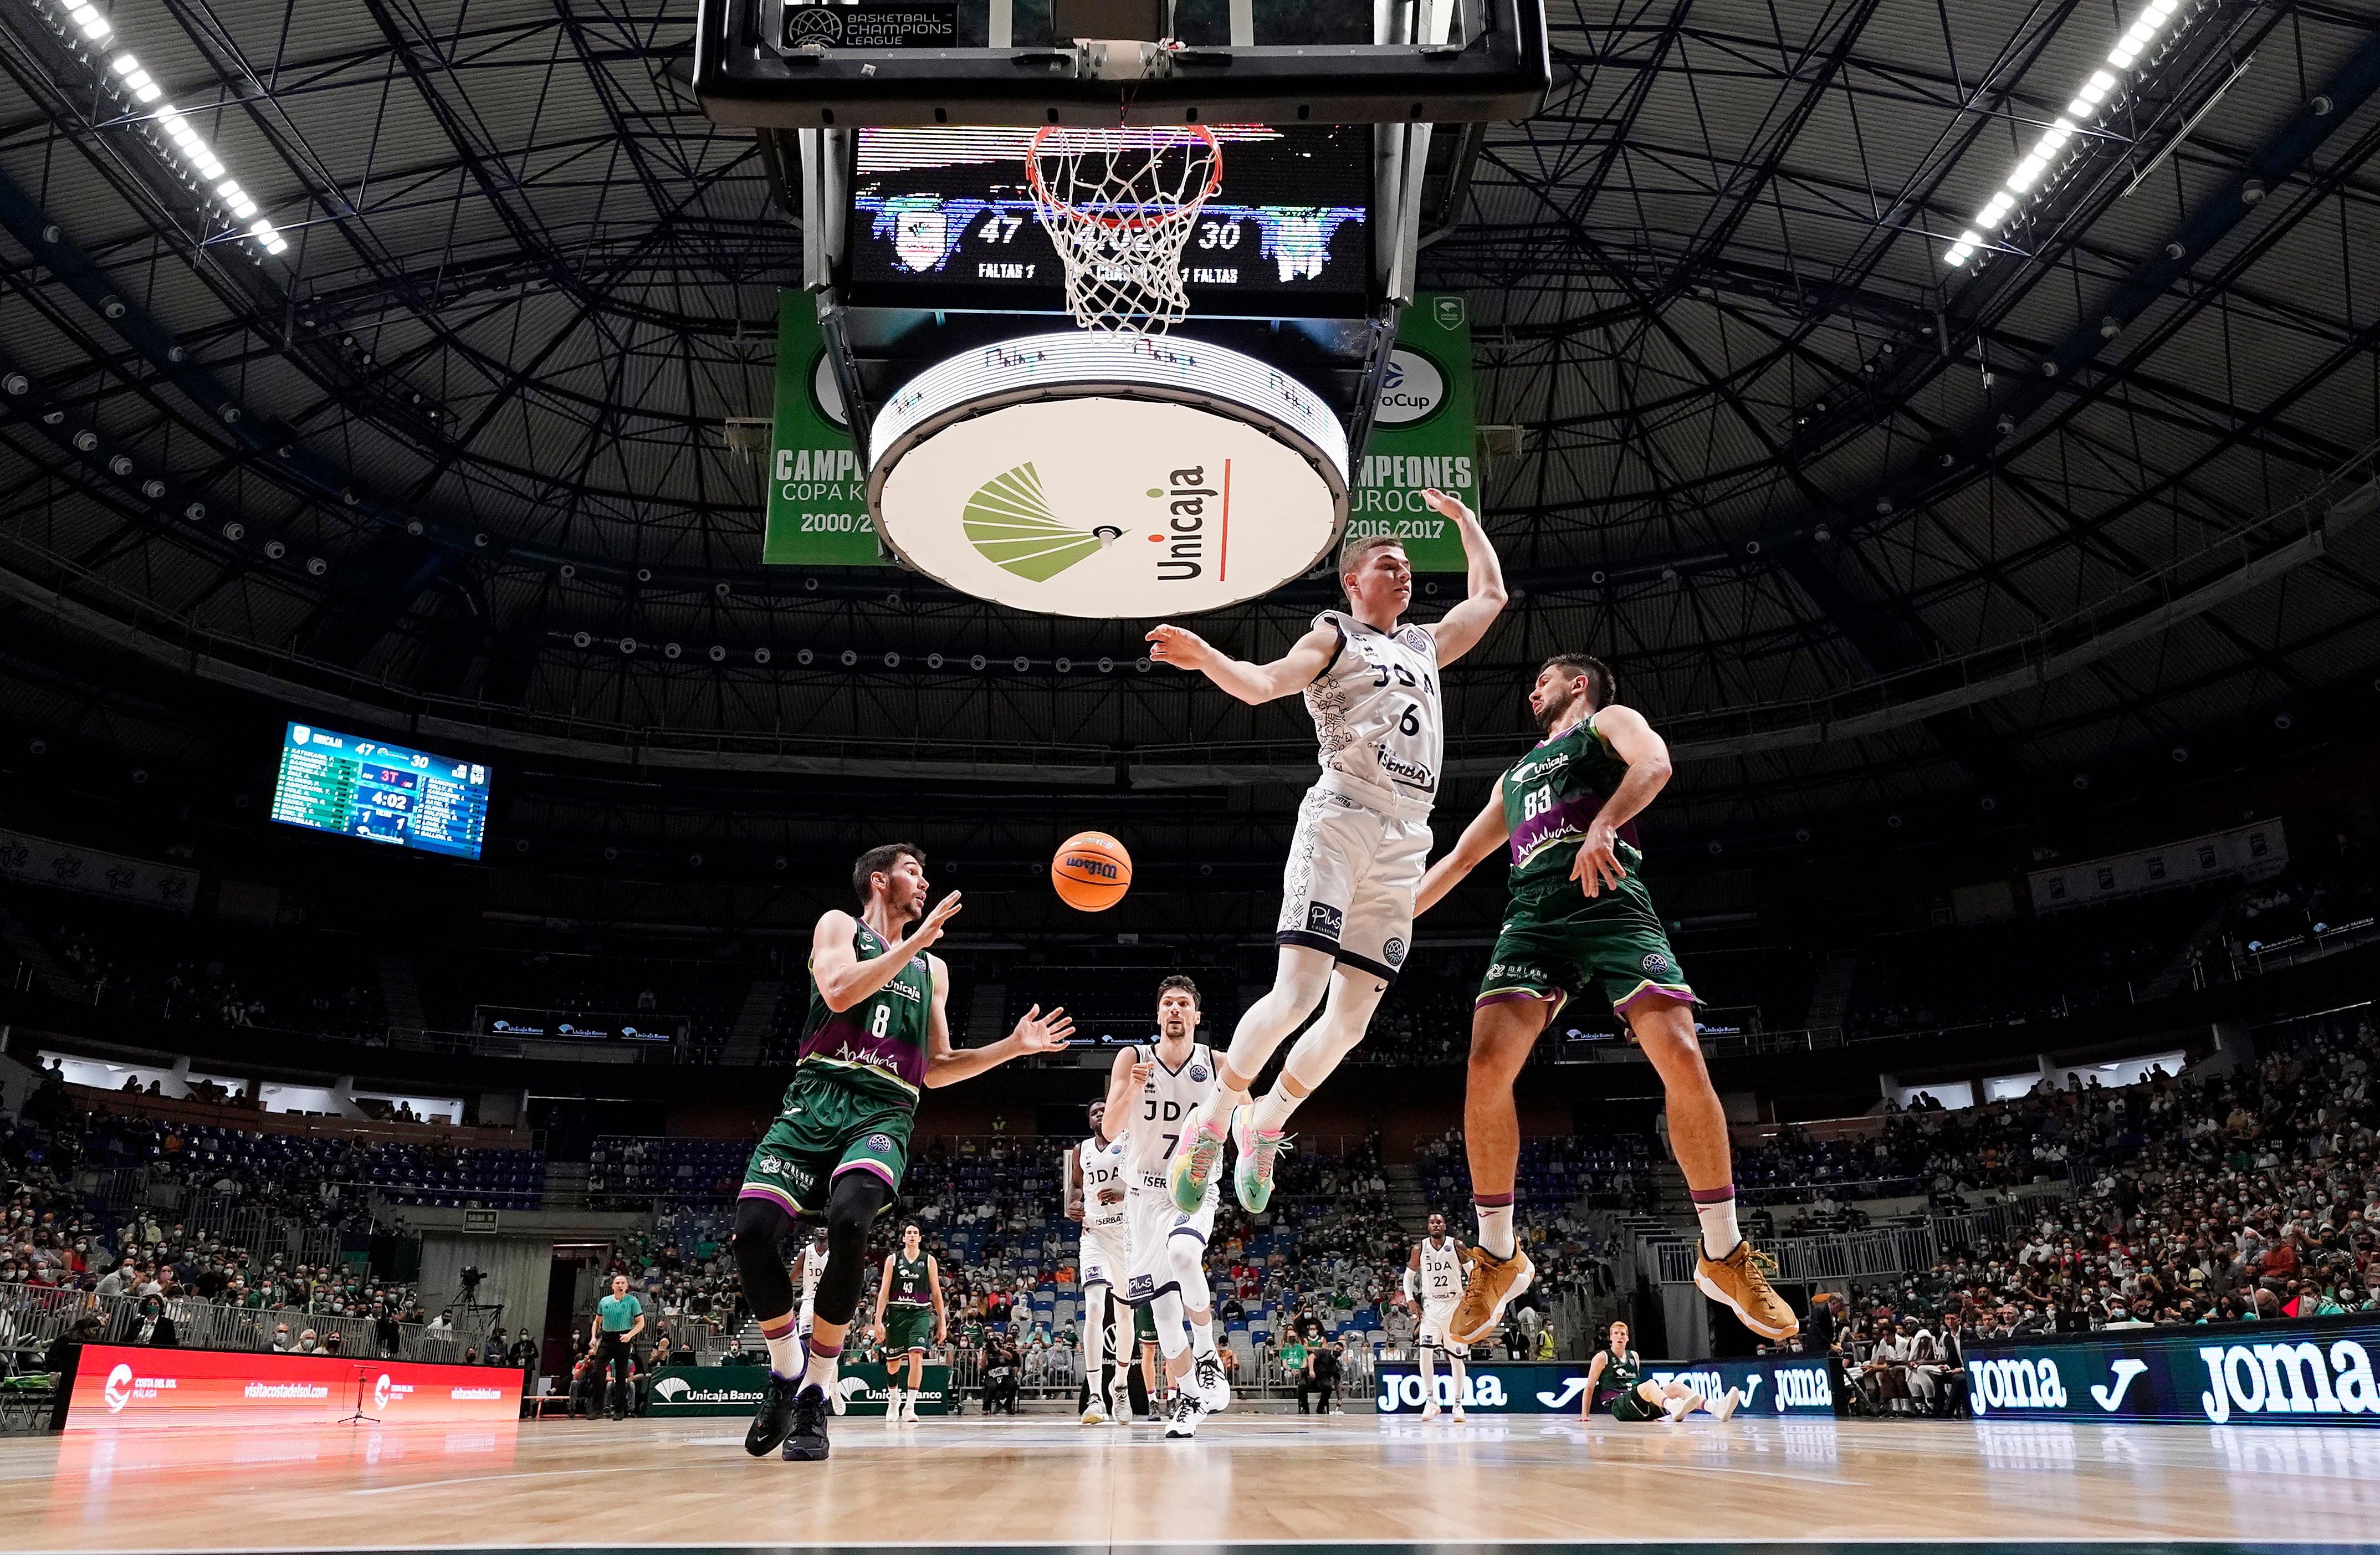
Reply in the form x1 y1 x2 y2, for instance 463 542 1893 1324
1026 124 1224 336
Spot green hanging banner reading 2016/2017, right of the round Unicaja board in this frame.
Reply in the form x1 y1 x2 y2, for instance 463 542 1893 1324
1347 290 1480 571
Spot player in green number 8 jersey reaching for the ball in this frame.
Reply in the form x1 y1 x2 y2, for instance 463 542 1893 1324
735 843 1073 1460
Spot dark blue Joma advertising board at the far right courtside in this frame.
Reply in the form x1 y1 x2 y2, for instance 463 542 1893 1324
1966 1312 2380 1426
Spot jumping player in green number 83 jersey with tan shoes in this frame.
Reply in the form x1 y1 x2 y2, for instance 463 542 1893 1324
1414 652 1801 1343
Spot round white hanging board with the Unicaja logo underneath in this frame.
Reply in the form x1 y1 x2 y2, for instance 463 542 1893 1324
869 331 1347 619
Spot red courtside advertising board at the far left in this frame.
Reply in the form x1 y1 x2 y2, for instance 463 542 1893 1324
66 1346 521 1431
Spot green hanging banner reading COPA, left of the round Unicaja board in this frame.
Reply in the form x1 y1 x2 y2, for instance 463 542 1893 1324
759 290 886 567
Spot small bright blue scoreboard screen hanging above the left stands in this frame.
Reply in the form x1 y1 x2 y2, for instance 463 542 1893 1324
274 724 488 860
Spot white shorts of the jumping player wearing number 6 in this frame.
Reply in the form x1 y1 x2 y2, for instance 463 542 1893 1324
1273 786 1430 981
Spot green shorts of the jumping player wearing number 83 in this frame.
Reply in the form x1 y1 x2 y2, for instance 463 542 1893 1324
1478 862 1695 1021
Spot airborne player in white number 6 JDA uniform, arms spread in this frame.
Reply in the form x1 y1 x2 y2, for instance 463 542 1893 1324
1149 490 1504 1212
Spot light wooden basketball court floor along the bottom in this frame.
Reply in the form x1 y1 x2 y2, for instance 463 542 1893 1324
0 1414 2380 1550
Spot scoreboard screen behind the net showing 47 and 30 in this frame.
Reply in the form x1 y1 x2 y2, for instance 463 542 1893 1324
845 124 1371 317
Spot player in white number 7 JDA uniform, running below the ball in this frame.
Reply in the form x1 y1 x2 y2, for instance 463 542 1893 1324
1099 976 1231 1436
